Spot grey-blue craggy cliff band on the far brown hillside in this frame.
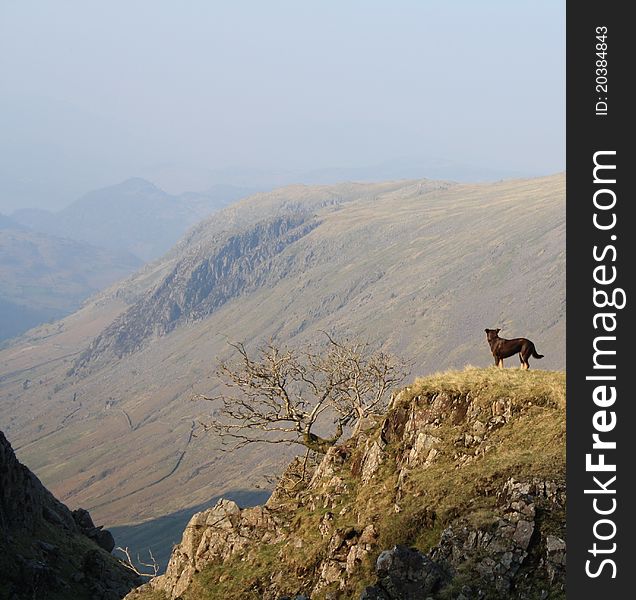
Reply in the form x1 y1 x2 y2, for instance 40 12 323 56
71 213 319 374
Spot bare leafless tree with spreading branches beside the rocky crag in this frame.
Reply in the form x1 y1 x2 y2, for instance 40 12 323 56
195 334 406 454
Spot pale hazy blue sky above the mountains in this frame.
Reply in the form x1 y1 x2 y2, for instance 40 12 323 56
0 0 565 212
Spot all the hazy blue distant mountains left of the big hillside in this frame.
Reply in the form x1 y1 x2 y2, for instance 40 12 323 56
0 177 253 340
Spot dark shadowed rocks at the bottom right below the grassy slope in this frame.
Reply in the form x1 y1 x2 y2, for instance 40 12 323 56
360 479 566 600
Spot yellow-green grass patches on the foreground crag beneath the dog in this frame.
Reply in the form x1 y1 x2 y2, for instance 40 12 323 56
159 368 565 600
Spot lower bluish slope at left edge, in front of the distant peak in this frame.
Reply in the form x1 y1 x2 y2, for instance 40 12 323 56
0 229 141 341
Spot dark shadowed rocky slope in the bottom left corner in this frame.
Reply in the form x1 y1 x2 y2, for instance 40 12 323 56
0 432 140 600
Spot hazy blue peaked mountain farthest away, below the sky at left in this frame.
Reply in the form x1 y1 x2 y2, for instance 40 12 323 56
12 178 252 262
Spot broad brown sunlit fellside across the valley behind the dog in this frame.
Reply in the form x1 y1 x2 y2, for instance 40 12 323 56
0 175 565 564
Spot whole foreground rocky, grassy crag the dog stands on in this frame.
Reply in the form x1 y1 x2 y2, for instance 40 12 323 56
126 367 566 600
